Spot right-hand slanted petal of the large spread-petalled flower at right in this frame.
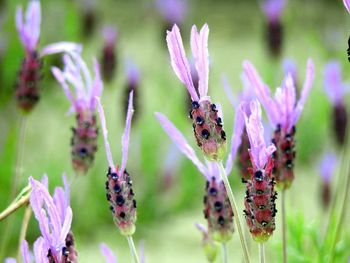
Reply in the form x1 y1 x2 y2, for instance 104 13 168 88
291 58 315 125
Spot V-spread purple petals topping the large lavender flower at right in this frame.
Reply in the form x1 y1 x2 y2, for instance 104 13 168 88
243 59 314 132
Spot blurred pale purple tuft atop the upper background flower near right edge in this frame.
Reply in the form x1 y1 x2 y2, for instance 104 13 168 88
324 61 345 105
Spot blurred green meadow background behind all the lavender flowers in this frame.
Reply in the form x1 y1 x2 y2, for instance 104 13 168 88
0 0 350 262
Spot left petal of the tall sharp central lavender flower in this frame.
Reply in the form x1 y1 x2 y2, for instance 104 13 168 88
166 25 199 101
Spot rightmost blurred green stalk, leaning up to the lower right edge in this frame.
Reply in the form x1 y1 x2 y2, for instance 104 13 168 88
328 158 350 262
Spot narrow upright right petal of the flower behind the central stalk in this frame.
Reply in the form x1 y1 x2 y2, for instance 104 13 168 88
226 107 245 175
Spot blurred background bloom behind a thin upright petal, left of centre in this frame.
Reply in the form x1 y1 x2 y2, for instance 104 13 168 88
124 59 140 123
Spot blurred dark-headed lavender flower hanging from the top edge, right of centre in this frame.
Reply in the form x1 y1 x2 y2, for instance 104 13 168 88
261 0 286 57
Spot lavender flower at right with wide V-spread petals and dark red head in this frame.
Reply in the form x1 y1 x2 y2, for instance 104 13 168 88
243 59 314 189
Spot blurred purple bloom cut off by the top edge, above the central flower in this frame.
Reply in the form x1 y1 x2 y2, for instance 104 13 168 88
156 0 188 24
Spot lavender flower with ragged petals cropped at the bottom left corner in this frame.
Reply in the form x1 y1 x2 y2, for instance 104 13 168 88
7 176 78 263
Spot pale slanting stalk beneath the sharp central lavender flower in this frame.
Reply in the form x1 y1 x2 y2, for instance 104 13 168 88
218 162 250 263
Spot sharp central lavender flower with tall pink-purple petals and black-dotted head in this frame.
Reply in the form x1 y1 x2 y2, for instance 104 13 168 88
166 24 226 161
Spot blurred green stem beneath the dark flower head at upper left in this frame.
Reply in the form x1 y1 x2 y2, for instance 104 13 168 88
11 116 27 198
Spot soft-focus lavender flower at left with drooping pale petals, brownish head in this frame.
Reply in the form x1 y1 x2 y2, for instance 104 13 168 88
52 52 103 173
